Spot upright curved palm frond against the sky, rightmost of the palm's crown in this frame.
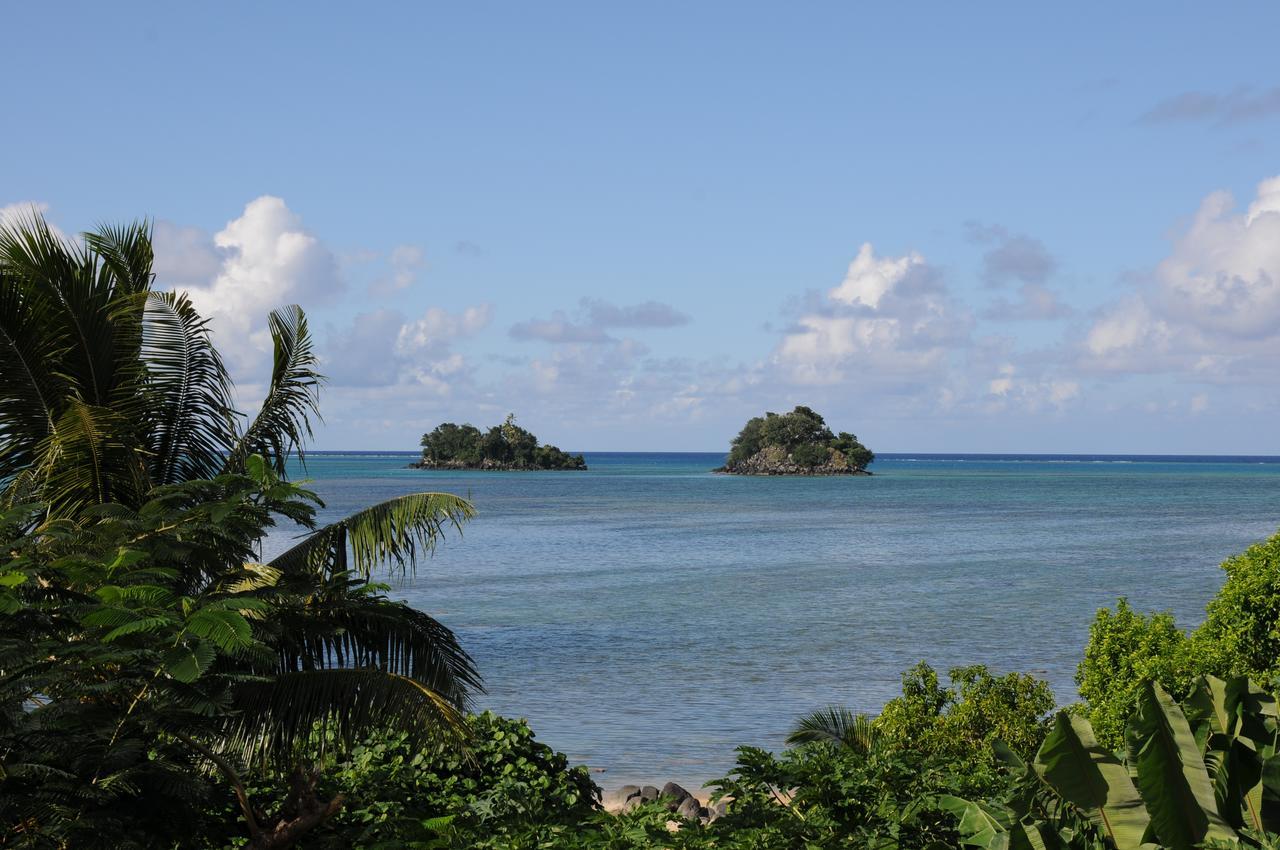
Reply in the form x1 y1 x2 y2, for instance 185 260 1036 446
225 305 324 475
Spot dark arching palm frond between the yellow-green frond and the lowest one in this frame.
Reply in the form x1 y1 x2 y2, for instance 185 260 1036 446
266 594 484 710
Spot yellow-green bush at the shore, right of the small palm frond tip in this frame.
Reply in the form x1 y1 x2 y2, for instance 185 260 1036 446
877 662 1055 763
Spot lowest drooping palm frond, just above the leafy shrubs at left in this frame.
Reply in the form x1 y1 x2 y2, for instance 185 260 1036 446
220 668 466 764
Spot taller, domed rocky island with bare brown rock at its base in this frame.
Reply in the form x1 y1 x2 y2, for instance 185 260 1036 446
716 406 876 475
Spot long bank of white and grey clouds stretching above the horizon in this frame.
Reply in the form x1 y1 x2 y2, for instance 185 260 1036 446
10 177 1280 451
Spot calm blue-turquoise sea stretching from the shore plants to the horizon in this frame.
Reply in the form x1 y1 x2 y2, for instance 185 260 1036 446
273 453 1280 787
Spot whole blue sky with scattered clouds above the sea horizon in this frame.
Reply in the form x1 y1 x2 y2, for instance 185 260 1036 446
0 1 1280 454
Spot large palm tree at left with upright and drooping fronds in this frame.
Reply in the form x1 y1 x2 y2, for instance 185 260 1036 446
0 213 481 847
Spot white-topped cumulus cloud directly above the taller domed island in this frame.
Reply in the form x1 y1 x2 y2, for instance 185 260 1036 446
772 243 972 384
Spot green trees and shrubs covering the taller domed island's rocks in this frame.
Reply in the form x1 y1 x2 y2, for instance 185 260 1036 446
724 406 876 471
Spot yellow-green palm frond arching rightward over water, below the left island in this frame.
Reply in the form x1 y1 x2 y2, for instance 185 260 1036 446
271 493 475 579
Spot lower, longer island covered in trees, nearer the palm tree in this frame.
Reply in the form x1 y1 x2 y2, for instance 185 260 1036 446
410 413 586 471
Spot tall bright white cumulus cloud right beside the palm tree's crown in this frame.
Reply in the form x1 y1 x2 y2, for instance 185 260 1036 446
155 195 342 371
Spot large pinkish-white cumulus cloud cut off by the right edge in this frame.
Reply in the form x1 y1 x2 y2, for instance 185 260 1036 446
1083 178 1280 379
